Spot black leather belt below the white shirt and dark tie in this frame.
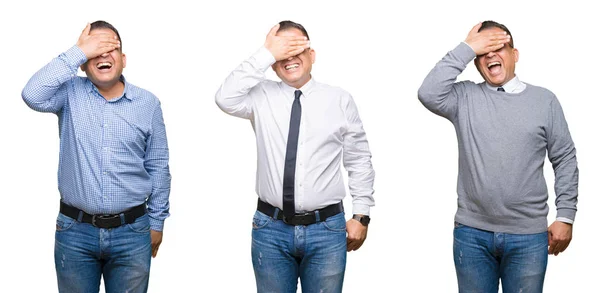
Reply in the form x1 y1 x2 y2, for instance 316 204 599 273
256 199 344 226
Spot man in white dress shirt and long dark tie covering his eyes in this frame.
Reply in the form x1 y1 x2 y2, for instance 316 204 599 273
216 21 375 292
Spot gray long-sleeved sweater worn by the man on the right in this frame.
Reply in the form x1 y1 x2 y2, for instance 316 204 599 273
419 43 578 234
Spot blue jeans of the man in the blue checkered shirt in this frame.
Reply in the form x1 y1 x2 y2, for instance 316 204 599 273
54 214 151 293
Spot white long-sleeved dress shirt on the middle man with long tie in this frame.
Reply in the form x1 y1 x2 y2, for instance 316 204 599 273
215 47 375 215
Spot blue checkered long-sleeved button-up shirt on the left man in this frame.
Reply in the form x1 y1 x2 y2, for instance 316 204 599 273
22 46 171 231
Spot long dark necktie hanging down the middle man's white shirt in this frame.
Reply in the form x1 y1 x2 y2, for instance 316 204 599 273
283 90 302 220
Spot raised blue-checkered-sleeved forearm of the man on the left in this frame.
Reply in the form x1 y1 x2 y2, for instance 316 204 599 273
21 46 87 113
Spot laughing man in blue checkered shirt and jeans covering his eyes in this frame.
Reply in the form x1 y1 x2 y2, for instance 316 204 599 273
22 21 171 293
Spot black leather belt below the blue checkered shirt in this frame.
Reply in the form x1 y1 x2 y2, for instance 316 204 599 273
60 201 146 229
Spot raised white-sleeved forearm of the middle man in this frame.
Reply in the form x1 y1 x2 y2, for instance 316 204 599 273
215 47 275 118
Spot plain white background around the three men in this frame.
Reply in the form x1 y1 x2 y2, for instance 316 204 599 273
0 0 600 292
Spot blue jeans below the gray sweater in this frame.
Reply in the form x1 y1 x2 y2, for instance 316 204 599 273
454 223 548 293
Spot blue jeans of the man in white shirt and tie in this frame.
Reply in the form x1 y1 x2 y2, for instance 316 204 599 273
252 211 346 293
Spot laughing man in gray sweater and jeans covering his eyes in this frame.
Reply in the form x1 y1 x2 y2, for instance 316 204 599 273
419 21 578 293
